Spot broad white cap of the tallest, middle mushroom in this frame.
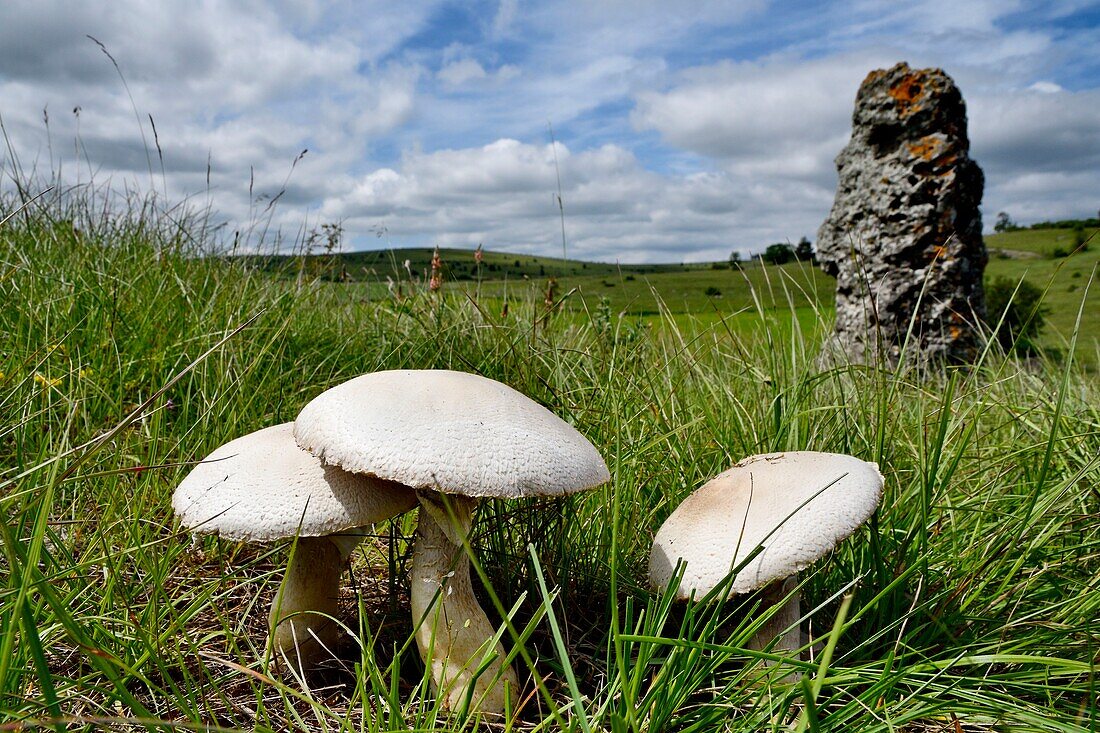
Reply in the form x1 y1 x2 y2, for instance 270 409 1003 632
294 370 611 497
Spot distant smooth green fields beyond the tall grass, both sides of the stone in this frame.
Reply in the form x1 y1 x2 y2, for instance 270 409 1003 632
281 228 1100 356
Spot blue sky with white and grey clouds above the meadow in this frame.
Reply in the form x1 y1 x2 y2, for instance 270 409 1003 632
0 0 1100 262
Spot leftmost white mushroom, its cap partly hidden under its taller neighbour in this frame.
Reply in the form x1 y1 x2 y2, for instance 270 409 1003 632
172 423 416 667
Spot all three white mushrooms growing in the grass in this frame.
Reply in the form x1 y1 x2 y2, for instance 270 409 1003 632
173 370 882 715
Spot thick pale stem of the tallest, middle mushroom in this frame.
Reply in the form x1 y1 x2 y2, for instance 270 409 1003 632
410 491 518 714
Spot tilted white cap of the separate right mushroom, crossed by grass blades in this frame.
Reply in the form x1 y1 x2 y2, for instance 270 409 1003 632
649 451 882 599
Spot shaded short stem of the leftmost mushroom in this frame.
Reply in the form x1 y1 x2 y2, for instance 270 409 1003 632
270 537 349 668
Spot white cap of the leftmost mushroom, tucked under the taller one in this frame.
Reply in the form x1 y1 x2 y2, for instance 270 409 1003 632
172 423 417 541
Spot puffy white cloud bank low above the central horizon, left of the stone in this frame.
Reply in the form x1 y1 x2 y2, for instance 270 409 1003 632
321 139 792 262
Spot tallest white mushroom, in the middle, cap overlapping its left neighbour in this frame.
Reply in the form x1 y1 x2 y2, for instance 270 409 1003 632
295 370 611 714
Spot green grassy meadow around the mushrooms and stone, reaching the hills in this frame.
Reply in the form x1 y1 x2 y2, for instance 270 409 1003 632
0 190 1100 733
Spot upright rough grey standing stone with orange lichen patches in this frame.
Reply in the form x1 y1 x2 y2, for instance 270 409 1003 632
816 63 988 364
